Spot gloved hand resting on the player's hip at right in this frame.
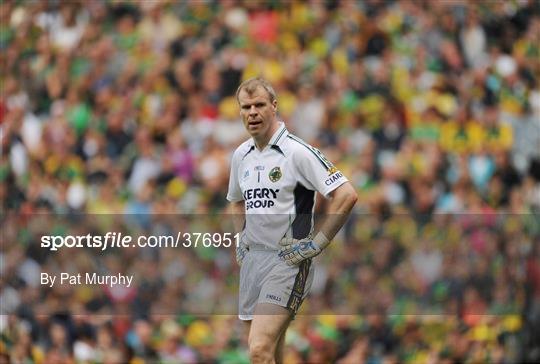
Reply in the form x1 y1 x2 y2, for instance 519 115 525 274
278 232 330 266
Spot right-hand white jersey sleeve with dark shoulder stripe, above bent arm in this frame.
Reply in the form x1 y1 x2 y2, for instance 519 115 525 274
294 144 348 197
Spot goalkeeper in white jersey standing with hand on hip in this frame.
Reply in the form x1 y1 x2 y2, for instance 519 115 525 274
227 78 357 363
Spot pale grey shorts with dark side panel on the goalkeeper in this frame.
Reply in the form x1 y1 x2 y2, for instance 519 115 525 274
238 247 313 320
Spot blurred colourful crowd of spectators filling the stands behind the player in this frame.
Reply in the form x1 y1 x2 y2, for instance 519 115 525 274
0 0 540 363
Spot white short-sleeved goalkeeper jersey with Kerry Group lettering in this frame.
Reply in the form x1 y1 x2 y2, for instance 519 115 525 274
227 122 347 250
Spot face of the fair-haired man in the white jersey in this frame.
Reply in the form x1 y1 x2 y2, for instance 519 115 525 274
238 86 277 142
